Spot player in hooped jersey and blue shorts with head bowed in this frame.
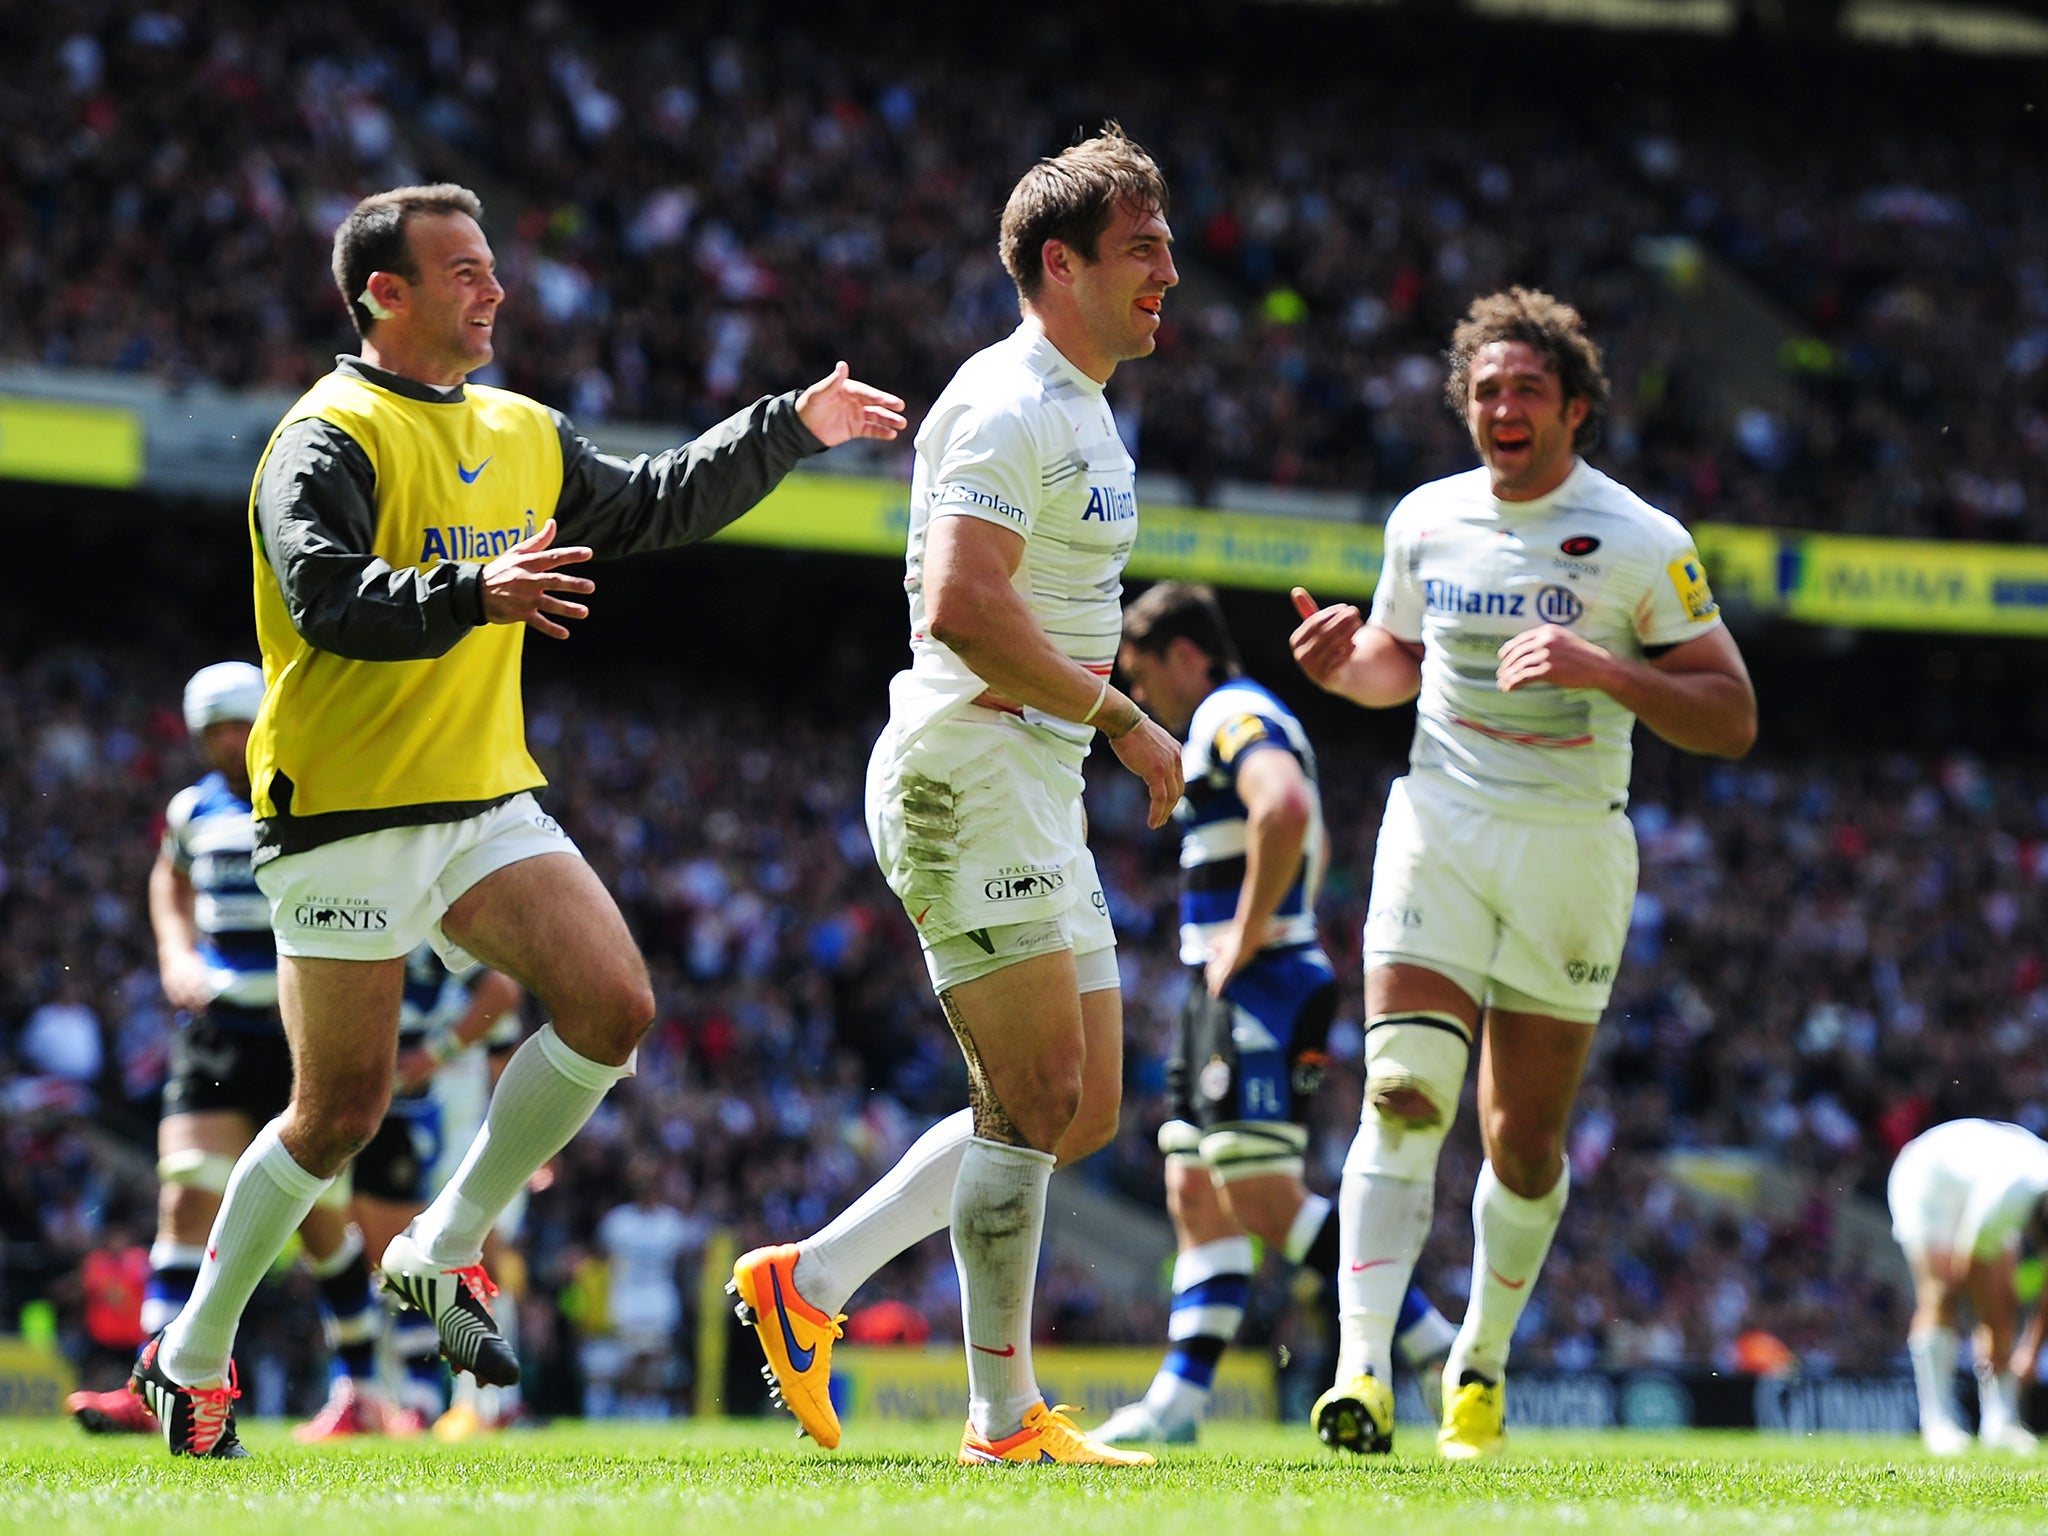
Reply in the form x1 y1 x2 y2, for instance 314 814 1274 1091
1096 582 1452 1444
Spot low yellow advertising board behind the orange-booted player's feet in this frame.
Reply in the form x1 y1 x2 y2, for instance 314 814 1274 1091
831 1343 1280 1425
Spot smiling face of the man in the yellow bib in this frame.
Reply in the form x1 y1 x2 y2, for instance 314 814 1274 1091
365 213 506 385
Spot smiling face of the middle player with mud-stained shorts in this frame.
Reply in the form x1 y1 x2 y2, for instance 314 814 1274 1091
1030 205 1180 383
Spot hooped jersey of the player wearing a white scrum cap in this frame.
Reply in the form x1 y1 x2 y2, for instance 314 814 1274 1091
164 774 283 1030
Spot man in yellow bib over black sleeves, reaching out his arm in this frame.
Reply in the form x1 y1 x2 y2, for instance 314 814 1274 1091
131 186 903 1456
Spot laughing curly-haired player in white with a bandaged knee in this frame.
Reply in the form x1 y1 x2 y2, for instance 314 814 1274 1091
1292 289 1757 1460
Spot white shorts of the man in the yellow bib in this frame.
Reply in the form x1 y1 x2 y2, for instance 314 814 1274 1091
256 795 582 973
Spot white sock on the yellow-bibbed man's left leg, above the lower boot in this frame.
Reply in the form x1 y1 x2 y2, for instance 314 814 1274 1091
160 1120 334 1386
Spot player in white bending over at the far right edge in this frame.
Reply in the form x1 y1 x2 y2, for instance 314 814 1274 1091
1884 1120 2048 1456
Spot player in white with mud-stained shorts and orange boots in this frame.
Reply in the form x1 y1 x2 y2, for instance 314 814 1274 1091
731 123 1182 1466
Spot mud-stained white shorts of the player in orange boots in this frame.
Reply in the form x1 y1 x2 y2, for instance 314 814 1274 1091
866 705 1116 991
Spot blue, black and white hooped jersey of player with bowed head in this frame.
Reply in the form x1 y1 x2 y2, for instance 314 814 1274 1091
1174 678 1323 965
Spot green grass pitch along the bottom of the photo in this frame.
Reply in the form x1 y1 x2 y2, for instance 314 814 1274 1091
0 1419 2048 1536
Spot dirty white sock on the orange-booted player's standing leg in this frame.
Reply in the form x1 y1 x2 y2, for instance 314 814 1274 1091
952 1137 1053 1440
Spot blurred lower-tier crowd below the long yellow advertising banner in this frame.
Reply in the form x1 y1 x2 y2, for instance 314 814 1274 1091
0 593 2048 1411
